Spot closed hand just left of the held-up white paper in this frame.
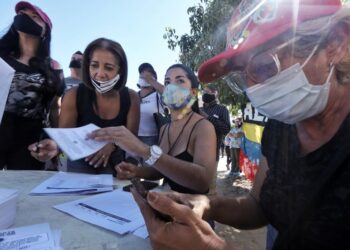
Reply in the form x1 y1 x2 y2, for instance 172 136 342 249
28 139 59 162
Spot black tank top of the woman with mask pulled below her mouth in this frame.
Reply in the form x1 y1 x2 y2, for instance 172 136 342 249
76 84 131 128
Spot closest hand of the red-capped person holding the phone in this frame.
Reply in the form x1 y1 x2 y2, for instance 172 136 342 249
131 189 233 250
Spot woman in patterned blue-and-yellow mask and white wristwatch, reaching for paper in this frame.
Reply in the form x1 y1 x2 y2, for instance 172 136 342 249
90 64 216 193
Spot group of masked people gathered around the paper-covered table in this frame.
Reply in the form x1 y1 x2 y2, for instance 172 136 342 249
0 0 350 249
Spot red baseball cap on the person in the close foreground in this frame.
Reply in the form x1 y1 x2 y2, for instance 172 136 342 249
198 0 342 83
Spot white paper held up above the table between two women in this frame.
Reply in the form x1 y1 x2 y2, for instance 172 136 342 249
44 123 107 161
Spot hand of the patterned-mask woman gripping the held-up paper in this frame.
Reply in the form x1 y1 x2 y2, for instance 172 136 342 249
88 126 149 159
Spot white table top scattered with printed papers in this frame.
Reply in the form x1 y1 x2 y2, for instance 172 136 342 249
0 170 152 250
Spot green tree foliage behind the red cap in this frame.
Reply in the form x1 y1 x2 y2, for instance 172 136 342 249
163 0 246 107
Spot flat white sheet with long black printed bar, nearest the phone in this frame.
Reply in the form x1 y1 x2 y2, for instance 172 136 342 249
54 189 145 234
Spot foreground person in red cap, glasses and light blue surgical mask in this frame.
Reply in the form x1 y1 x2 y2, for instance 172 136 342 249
129 0 350 249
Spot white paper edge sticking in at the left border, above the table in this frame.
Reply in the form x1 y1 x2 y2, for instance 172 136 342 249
0 58 15 124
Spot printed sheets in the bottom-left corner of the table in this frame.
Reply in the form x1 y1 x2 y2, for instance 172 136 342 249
0 223 62 250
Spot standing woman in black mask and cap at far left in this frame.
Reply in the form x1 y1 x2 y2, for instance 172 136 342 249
0 1 64 170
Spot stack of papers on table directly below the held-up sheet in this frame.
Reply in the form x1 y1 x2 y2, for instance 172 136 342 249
30 172 115 195
